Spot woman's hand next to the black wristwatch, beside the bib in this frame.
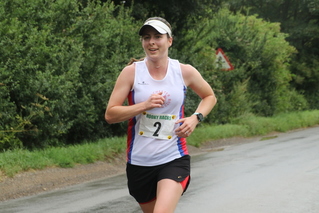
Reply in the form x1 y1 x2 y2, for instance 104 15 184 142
175 115 199 138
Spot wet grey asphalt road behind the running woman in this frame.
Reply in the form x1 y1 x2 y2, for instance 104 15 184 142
0 127 319 213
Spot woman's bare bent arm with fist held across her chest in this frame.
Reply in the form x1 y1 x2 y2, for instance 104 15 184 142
105 64 165 124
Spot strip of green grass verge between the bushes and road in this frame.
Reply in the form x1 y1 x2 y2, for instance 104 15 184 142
0 110 319 177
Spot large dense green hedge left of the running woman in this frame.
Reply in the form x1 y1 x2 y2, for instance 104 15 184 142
0 0 141 148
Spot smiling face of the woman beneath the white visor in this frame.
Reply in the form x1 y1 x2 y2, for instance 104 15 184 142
142 27 173 58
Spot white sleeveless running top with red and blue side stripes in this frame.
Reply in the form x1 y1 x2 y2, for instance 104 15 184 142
127 59 188 166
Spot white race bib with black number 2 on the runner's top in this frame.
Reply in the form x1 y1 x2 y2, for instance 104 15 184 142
139 112 176 140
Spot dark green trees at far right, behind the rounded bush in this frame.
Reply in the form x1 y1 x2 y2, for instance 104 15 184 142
228 0 319 109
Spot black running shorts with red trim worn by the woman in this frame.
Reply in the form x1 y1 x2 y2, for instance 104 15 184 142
126 155 190 204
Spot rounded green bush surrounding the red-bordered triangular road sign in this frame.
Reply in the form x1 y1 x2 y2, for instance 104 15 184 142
175 9 307 123
